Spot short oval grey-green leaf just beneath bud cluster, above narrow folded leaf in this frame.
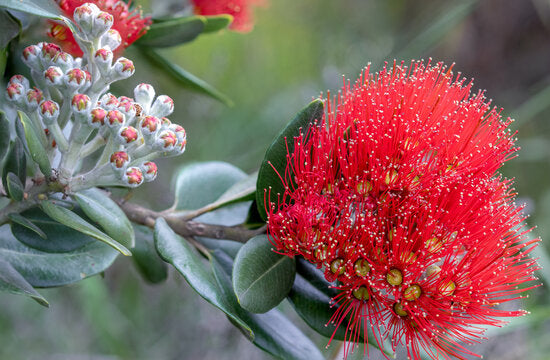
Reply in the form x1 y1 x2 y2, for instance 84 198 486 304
73 188 135 248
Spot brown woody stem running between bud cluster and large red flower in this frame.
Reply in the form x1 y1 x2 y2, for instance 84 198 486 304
117 200 265 243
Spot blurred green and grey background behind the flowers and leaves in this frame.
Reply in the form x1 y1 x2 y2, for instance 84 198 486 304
0 0 550 360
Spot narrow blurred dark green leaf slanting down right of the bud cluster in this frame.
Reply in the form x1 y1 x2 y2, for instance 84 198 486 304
140 47 233 106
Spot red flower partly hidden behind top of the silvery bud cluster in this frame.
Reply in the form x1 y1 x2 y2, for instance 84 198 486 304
48 0 151 56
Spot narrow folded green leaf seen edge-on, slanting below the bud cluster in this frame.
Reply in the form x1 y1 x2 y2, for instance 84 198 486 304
40 200 132 256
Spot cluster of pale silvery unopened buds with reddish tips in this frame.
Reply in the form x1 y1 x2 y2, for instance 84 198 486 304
6 3 186 191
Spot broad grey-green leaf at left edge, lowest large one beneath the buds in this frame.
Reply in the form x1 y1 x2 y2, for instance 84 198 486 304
0 225 118 287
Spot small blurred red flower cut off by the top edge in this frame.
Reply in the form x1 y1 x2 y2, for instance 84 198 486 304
191 0 265 32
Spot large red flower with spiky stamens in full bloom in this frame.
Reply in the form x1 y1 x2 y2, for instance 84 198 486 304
268 62 538 359
